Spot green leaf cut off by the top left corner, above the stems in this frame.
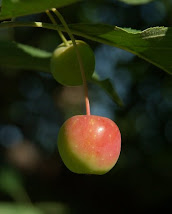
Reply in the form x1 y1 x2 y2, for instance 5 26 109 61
0 0 80 20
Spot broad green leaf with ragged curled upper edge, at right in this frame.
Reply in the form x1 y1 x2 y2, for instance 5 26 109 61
67 24 172 74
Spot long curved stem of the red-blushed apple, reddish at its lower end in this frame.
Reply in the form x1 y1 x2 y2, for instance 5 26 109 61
51 8 90 115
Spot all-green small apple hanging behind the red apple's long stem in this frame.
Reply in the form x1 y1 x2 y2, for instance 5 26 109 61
51 40 95 86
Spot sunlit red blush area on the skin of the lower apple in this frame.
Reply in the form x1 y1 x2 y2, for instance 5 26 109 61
59 115 121 173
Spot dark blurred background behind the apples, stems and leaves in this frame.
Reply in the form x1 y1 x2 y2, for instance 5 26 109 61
0 0 172 214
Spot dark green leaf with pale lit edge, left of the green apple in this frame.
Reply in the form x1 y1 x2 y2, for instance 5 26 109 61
0 41 51 72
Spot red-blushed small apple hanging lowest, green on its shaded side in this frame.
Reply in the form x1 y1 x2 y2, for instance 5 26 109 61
58 115 121 175
